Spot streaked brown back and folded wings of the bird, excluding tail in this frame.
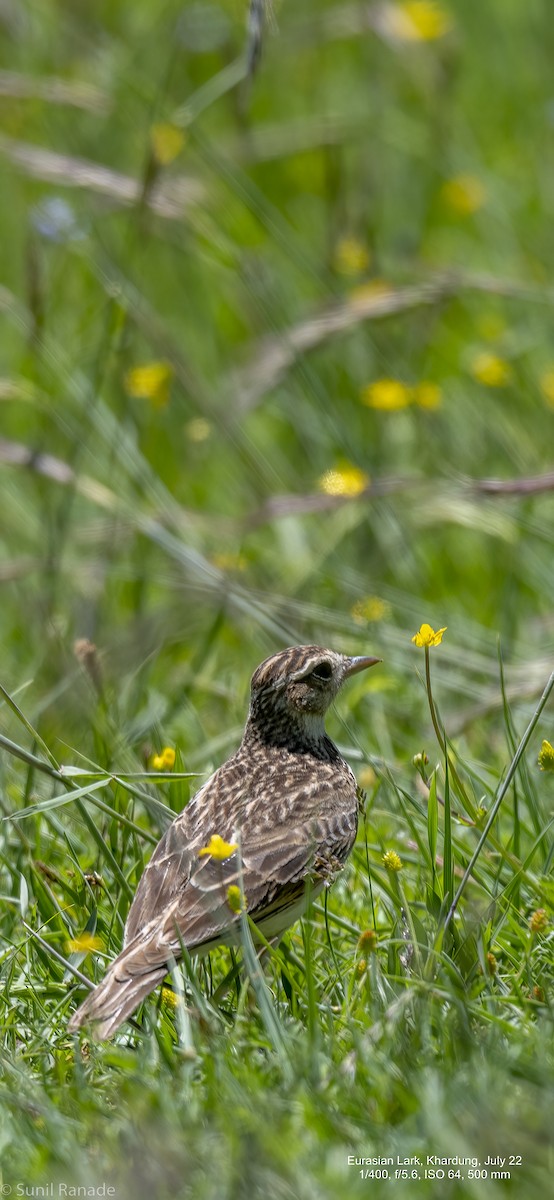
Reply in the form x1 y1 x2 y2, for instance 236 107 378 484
126 754 357 958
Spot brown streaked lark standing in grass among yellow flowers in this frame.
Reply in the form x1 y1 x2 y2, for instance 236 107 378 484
68 646 380 1039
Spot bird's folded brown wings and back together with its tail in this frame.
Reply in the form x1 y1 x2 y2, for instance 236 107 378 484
71 773 357 1038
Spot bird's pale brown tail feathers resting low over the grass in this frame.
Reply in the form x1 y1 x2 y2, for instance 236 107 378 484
67 938 168 1042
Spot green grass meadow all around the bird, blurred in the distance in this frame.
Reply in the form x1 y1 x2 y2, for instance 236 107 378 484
0 0 554 1200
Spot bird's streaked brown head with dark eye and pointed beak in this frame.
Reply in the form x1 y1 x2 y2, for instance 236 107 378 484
249 646 380 742
